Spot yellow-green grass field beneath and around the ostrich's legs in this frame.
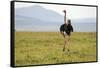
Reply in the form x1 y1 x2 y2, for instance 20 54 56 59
15 32 96 66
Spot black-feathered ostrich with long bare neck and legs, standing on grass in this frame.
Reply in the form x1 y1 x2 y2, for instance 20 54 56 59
60 10 73 51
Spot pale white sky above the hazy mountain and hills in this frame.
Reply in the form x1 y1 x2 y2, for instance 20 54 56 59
15 2 96 19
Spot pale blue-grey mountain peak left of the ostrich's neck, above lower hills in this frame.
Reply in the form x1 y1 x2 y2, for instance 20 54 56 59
16 6 63 22
